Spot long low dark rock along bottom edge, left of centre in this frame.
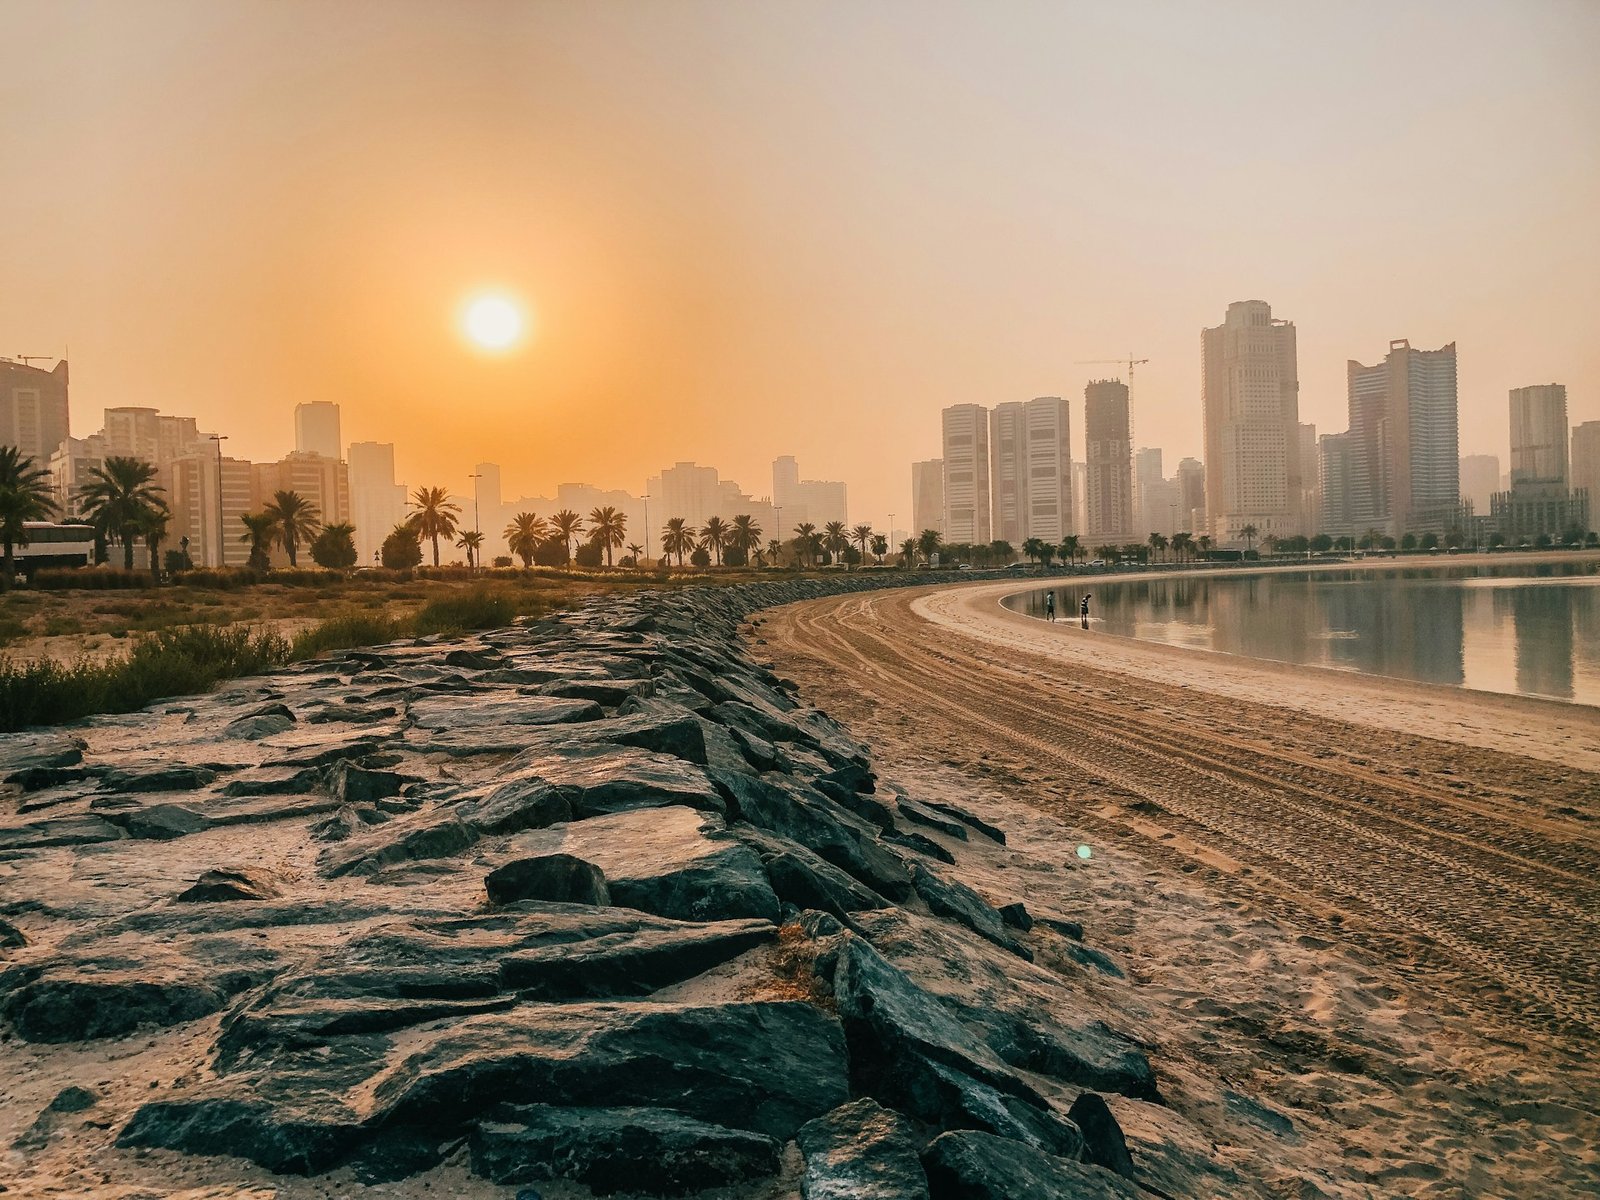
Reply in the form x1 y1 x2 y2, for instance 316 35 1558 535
470 1104 779 1195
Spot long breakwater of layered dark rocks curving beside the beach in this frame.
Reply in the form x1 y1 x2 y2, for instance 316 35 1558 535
0 579 1203 1200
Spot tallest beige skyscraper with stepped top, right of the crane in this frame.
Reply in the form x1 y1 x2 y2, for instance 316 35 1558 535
1200 301 1302 541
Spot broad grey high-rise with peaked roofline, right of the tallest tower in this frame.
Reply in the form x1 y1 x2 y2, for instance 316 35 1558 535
1346 345 1461 536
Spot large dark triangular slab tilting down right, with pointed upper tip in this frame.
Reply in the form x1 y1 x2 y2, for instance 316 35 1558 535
834 936 1082 1154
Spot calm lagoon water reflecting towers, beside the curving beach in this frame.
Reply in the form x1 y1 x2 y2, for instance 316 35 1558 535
1005 562 1600 706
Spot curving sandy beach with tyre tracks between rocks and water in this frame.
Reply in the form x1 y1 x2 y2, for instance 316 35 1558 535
758 576 1600 1197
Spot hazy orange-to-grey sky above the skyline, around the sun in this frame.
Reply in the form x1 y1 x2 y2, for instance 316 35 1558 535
0 0 1600 525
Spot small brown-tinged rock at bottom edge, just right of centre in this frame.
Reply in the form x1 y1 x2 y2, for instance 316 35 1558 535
795 1098 928 1200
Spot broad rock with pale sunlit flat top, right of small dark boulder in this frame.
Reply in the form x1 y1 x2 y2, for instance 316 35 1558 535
491 805 778 922
